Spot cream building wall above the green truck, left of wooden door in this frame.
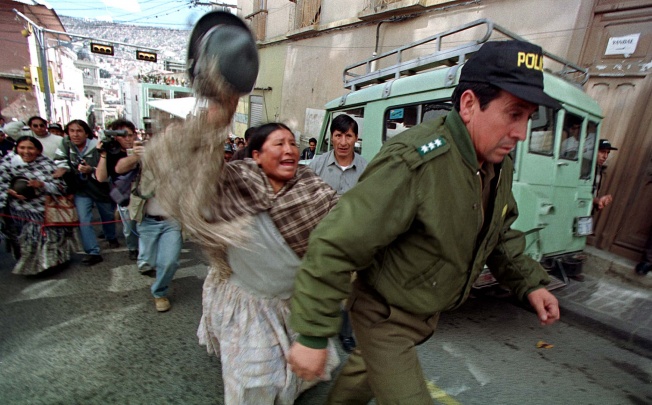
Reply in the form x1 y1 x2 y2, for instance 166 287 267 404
238 0 592 136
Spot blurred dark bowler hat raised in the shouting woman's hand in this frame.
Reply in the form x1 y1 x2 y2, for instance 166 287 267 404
187 11 258 93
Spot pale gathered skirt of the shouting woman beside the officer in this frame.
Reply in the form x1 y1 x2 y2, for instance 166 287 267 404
197 268 339 405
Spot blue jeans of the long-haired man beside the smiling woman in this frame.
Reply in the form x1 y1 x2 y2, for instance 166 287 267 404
75 194 115 255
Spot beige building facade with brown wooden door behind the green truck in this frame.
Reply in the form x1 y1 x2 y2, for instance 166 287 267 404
238 0 652 260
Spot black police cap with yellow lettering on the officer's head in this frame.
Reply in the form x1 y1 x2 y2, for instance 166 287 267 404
460 41 561 109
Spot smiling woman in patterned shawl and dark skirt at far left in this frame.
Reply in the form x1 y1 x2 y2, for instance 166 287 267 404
0 136 75 275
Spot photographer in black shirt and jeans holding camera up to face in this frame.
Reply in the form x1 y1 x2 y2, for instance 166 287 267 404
95 119 139 260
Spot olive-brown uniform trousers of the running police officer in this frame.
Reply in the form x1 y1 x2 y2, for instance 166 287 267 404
328 280 439 405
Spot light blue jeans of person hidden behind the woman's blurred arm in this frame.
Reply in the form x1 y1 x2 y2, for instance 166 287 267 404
138 216 183 298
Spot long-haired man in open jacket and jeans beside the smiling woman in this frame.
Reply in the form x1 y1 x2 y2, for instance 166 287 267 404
53 120 119 266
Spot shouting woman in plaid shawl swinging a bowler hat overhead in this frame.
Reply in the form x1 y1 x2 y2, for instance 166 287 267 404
144 12 339 405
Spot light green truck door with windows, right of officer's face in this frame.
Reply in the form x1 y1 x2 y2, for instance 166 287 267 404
514 107 597 256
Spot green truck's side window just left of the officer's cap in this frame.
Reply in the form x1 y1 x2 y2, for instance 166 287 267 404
383 102 453 143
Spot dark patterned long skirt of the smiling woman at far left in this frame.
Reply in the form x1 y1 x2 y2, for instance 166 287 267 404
7 209 79 275
